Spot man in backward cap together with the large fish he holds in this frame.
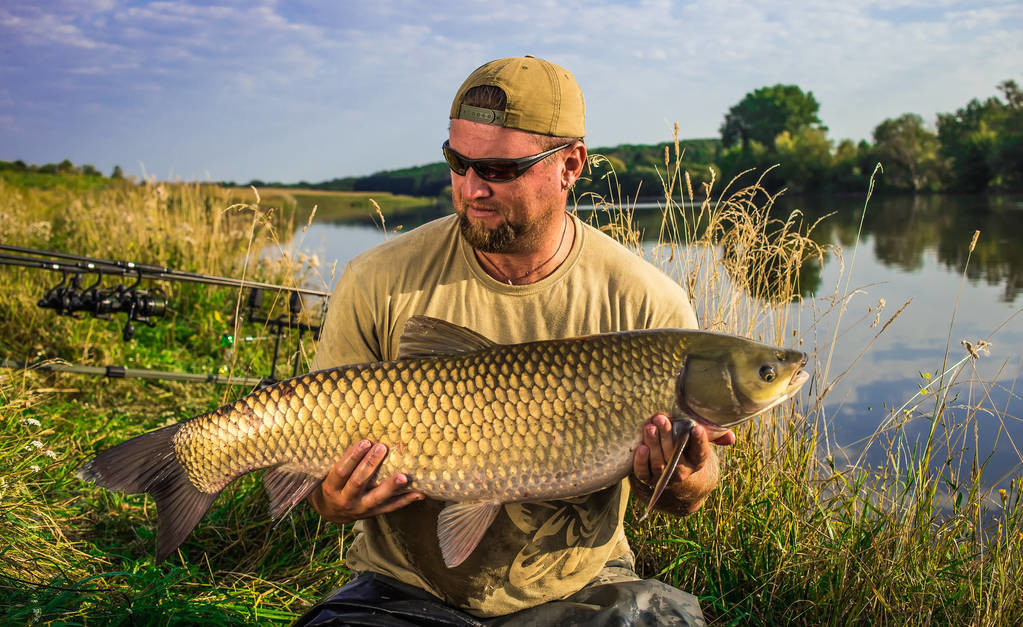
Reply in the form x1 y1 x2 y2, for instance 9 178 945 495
77 57 809 625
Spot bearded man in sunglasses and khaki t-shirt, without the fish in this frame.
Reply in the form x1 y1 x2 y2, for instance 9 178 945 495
300 56 735 625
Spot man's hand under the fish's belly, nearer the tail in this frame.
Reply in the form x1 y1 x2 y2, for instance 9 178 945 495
309 440 426 523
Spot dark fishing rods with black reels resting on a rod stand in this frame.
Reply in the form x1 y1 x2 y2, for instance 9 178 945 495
0 243 329 385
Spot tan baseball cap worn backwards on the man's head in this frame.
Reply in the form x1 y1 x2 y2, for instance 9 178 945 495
451 55 586 137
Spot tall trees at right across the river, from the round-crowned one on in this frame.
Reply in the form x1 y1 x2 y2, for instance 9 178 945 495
715 80 1023 192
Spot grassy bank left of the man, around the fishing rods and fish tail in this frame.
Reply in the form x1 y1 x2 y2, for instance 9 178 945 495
0 175 348 624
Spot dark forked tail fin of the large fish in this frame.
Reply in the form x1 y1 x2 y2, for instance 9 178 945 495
77 424 220 564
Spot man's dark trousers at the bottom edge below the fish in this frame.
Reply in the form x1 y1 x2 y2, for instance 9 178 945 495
295 559 706 627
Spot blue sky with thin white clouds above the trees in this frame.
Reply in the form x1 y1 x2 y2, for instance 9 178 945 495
0 0 1023 182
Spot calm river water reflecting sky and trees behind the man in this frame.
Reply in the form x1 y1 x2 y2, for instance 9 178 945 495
284 195 1023 486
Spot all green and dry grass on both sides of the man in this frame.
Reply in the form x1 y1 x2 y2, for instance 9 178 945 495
0 154 1023 625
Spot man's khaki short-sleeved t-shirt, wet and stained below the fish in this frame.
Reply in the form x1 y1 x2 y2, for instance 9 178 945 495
313 211 697 616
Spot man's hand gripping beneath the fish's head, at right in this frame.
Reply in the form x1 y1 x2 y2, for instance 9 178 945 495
632 413 736 513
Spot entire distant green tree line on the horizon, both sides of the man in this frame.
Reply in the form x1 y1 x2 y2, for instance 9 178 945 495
235 80 1023 197
